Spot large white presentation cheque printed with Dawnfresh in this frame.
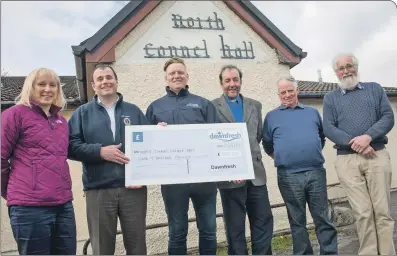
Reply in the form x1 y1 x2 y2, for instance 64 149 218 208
125 123 255 185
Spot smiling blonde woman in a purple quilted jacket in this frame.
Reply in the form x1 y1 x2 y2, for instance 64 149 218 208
1 68 76 255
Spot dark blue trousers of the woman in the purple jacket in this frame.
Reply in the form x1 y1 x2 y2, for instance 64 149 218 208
8 202 77 255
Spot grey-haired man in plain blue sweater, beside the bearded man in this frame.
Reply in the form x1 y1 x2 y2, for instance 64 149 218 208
263 77 338 255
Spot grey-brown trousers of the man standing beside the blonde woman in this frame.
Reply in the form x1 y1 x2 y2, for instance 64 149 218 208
86 187 147 255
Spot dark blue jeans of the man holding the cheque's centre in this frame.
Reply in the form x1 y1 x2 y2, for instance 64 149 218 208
161 183 217 255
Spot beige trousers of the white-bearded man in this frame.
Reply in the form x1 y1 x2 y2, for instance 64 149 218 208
335 149 396 255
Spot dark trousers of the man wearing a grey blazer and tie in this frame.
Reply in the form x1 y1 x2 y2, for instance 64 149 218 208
219 181 273 255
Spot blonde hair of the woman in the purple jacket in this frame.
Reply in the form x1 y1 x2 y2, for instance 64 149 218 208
15 68 66 109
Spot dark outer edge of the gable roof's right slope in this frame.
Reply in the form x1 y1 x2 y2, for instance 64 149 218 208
238 0 307 59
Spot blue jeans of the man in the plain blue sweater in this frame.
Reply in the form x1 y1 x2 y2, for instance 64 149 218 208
278 169 338 255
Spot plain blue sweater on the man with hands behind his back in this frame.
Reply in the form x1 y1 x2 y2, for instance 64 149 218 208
262 104 325 173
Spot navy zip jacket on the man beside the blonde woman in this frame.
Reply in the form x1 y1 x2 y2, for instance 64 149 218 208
68 94 148 191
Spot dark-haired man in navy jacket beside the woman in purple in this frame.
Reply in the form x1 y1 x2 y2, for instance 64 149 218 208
69 64 148 255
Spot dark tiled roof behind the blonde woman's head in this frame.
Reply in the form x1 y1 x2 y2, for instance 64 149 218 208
1 76 80 104
